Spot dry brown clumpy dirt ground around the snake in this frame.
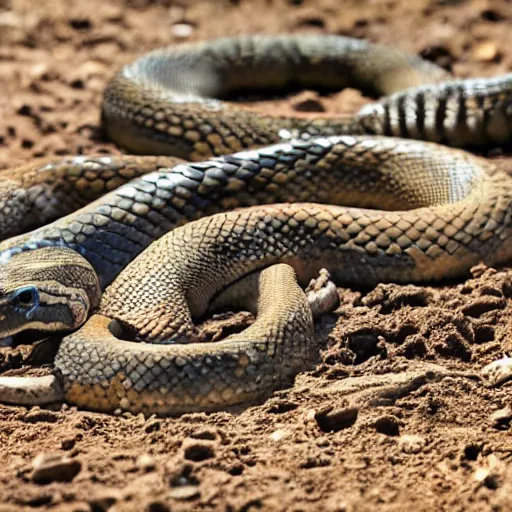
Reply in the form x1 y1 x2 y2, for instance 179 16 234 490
0 0 512 512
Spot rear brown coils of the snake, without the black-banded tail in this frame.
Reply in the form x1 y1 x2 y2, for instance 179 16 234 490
0 35 448 240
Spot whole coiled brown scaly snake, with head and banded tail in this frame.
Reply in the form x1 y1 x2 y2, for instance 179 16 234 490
0 35 512 414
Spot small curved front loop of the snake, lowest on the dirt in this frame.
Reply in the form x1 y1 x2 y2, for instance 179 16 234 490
56 266 318 415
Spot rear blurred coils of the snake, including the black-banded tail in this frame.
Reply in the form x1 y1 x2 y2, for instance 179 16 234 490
0 34 512 240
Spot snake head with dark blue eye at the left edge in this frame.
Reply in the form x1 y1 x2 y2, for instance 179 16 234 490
0 247 100 338
